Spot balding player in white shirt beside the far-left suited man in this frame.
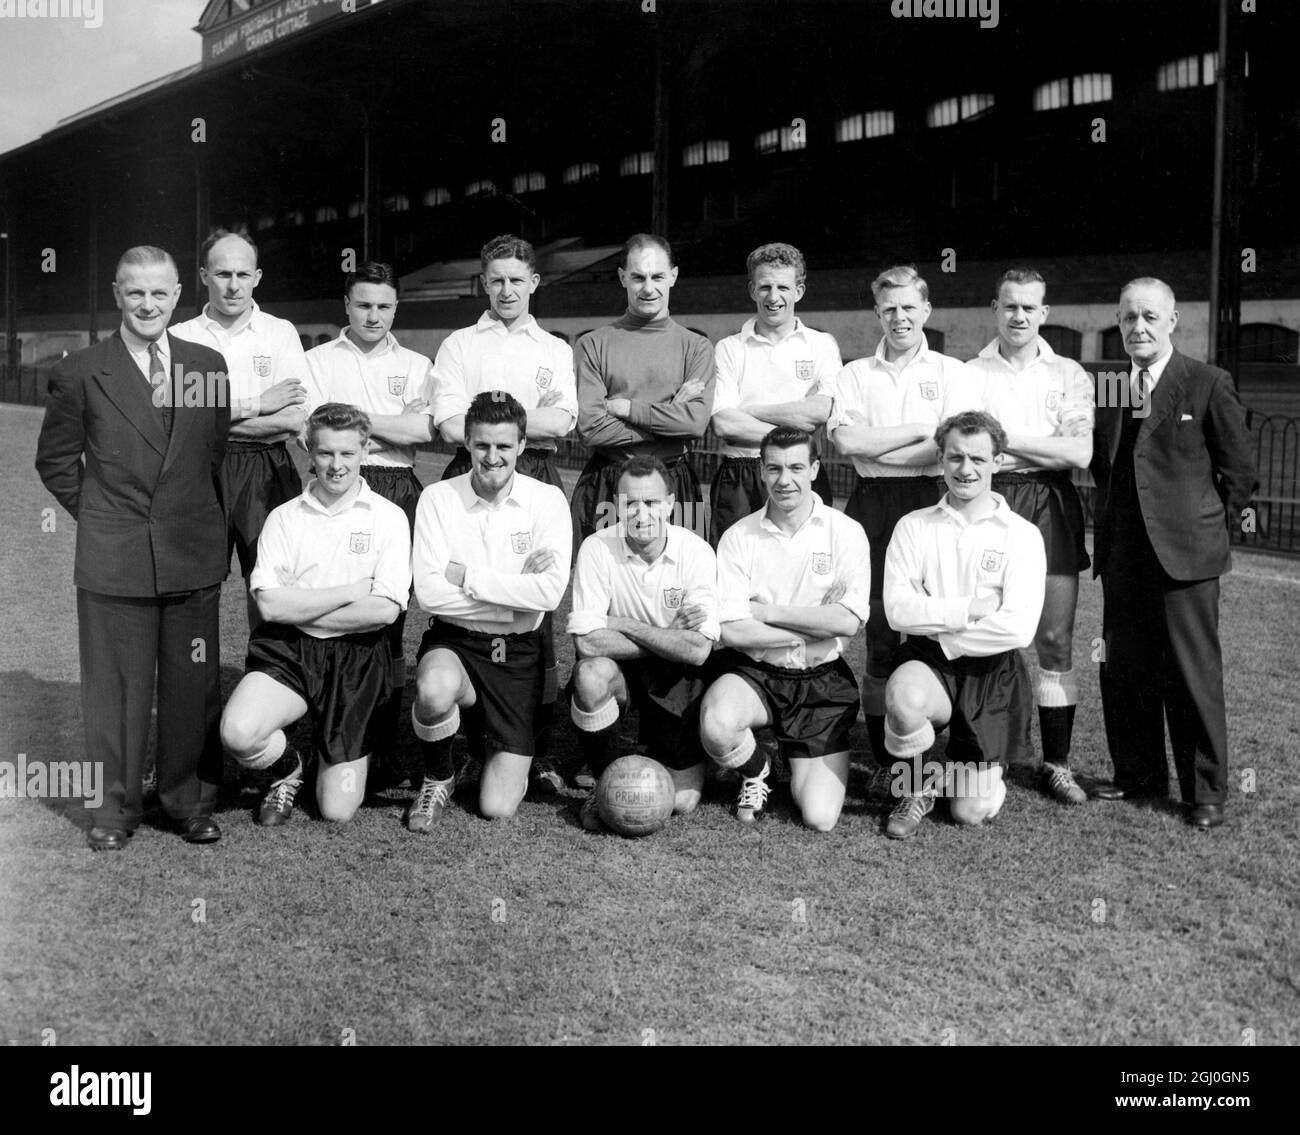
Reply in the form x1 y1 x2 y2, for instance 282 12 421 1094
172 229 308 629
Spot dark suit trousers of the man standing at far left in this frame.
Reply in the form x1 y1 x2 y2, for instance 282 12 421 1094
77 584 222 831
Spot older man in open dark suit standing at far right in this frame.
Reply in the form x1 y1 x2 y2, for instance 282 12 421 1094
1092 277 1256 829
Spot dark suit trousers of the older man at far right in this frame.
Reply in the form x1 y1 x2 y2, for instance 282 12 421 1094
1101 538 1227 803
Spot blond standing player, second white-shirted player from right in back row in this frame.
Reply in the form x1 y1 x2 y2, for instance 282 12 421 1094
828 265 979 785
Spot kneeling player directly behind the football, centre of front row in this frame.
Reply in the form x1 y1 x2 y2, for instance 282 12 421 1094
568 454 719 831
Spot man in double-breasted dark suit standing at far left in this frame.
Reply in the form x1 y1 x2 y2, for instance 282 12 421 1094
36 246 230 850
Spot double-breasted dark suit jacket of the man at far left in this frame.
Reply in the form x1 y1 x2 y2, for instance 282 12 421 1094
36 333 230 597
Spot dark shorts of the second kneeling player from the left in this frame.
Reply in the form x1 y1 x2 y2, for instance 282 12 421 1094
416 618 546 761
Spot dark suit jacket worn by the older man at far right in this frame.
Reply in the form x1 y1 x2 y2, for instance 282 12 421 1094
1092 351 1258 580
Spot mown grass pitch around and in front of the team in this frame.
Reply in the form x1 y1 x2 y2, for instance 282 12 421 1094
0 407 1300 1045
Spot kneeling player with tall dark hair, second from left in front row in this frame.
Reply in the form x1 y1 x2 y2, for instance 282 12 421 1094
407 390 573 833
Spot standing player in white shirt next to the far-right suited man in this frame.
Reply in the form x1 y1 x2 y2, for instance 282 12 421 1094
969 268 1093 805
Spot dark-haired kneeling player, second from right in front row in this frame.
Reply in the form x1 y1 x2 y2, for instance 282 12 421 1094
699 426 871 832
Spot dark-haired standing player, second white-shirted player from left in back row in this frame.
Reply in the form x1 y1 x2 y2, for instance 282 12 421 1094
307 260 433 779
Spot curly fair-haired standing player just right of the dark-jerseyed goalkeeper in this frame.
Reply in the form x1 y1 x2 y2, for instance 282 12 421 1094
709 244 841 547
